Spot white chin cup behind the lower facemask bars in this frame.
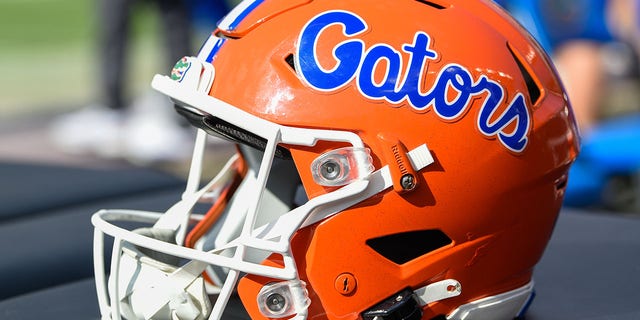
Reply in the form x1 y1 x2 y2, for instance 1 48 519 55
110 229 211 320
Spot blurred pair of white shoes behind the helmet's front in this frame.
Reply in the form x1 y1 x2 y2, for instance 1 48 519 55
50 92 195 164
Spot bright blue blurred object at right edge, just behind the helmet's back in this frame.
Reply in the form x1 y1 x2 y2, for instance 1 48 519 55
565 114 640 210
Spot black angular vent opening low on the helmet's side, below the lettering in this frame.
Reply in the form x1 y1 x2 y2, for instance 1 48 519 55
366 229 452 264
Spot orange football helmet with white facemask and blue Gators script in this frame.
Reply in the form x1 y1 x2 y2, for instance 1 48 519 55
92 0 579 320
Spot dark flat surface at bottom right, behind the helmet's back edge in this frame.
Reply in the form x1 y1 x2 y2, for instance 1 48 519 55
527 209 640 320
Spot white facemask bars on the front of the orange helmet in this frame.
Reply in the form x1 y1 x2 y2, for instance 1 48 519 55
92 72 366 319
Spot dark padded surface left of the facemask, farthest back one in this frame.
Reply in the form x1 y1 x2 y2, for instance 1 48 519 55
0 162 183 223
